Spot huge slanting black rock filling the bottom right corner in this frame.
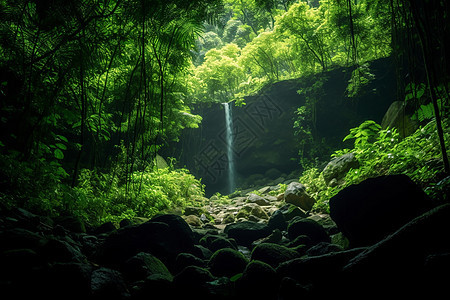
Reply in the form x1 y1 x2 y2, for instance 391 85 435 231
340 204 450 298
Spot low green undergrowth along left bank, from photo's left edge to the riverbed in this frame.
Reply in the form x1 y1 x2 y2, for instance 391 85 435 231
0 150 204 225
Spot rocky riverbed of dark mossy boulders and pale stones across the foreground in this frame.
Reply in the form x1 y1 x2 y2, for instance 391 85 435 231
0 175 450 299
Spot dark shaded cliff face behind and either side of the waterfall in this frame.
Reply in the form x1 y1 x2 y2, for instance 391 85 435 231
171 58 396 194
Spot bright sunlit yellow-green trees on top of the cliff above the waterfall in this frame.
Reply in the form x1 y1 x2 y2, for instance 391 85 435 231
190 0 391 102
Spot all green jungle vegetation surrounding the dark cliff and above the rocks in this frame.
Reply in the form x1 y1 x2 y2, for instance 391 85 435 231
0 0 450 223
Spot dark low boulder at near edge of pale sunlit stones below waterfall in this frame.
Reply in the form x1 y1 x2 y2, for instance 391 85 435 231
225 221 272 246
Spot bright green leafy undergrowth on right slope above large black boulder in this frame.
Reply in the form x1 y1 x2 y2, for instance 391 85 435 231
300 119 450 212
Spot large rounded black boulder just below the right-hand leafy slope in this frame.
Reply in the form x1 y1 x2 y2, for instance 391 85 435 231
330 175 430 247
